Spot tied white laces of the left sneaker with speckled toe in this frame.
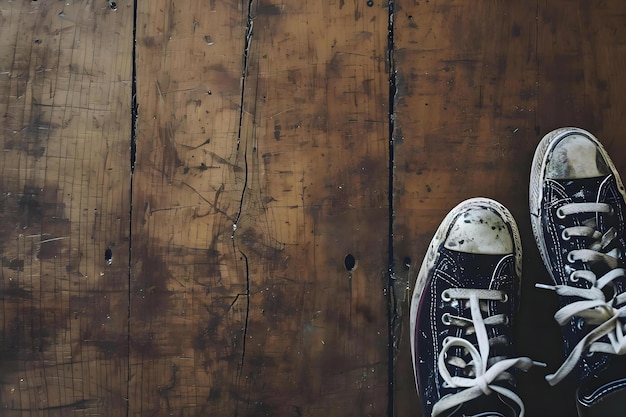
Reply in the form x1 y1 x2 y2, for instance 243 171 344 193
432 288 545 417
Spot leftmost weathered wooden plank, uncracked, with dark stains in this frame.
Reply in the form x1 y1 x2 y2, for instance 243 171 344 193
0 1 132 416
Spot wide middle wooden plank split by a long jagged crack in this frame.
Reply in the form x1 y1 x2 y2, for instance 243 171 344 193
130 1 388 416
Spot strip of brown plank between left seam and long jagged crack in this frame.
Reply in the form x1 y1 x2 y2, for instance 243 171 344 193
130 1 247 416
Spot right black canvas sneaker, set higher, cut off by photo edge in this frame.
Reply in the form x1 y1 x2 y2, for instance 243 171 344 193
529 127 626 417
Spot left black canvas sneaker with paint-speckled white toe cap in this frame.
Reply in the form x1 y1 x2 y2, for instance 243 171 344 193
410 198 533 417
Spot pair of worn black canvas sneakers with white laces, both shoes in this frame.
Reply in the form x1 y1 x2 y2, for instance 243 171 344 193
410 128 626 417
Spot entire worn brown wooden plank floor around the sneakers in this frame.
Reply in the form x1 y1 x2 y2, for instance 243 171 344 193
0 0 626 417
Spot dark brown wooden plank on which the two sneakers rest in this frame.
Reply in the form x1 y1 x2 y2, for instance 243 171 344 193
394 0 626 416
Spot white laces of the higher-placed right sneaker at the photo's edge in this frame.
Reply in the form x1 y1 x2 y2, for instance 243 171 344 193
536 203 626 385
